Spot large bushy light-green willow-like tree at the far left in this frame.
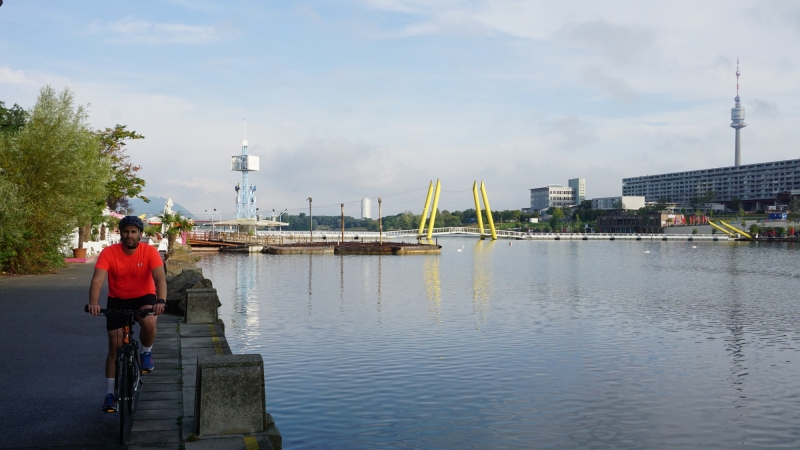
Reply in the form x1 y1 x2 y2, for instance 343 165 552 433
0 86 111 273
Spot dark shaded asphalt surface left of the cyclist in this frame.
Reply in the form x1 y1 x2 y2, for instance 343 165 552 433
0 264 121 449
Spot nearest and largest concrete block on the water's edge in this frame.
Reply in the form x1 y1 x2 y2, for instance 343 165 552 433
194 355 268 436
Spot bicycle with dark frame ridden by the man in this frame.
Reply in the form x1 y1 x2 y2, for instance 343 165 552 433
84 305 153 444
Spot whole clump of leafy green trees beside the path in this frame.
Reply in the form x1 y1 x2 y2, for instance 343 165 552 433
0 86 145 273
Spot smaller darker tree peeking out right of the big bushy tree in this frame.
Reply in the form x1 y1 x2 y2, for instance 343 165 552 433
96 124 150 212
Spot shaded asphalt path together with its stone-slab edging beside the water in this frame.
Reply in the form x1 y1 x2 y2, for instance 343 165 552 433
0 264 280 450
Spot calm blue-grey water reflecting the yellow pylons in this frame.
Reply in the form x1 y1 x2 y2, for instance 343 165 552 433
201 238 800 449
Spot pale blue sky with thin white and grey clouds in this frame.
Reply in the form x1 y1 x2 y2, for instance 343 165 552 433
0 0 800 217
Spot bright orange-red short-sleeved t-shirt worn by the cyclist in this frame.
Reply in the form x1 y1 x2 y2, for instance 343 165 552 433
94 243 164 299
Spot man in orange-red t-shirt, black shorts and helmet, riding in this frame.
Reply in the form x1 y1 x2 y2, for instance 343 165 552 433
89 216 167 412
